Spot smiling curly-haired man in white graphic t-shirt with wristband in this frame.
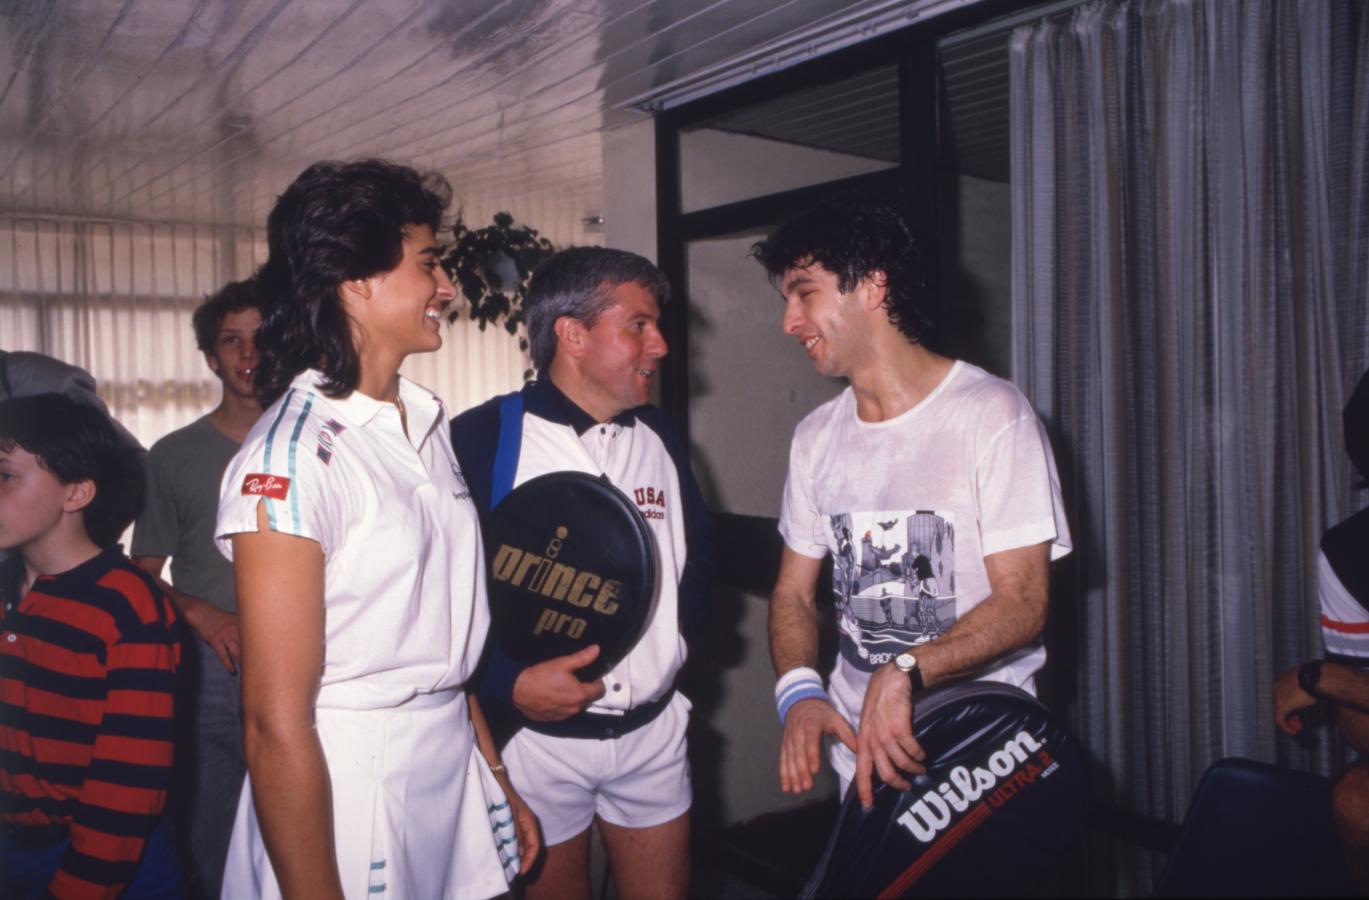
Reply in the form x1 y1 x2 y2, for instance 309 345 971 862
753 196 1069 807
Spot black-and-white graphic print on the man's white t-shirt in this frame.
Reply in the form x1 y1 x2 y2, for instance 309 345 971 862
828 510 956 671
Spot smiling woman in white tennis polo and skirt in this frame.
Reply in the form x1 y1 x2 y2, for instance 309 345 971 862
216 160 537 899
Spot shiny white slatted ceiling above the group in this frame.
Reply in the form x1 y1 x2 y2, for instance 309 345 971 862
0 0 971 226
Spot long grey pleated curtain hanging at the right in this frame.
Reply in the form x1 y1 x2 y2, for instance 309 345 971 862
1010 0 1369 893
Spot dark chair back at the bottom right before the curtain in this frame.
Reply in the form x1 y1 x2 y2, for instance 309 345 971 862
1155 758 1351 897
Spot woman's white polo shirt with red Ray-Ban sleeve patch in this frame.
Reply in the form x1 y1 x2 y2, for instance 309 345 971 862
215 370 489 710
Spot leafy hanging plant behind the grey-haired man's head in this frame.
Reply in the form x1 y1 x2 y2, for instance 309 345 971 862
442 212 556 351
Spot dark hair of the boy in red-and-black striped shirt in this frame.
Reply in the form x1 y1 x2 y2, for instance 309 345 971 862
0 393 146 548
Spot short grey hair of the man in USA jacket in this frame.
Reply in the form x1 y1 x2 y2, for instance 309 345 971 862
523 247 671 373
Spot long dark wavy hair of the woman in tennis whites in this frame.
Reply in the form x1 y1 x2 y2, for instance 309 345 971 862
252 159 452 405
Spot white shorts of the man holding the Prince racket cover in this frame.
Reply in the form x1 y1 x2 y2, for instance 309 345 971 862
504 693 693 845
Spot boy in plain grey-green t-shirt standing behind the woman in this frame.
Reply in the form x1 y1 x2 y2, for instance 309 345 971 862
133 281 261 897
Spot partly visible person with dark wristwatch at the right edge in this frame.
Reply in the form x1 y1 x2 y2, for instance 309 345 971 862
1275 371 1369 892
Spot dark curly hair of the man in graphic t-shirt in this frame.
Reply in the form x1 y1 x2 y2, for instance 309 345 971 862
752 193 941 345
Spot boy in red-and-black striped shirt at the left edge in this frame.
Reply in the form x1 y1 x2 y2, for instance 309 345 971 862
0 393 179 899
